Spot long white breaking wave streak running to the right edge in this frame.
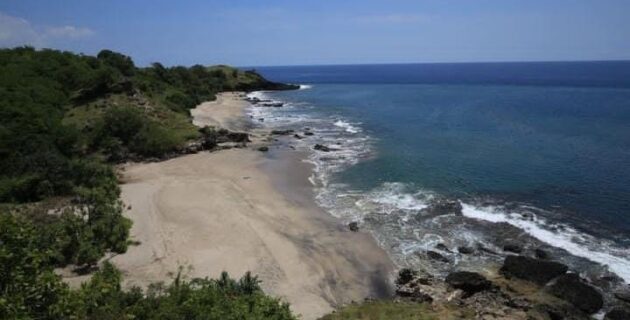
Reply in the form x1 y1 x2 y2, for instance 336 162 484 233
462 203 630 282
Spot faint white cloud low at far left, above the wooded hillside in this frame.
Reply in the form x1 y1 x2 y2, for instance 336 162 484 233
0 12 94 47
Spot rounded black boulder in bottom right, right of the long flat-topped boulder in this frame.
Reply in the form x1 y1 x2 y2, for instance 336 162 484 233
548 273 604 314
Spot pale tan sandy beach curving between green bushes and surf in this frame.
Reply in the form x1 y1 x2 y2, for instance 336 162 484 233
112 93 393 319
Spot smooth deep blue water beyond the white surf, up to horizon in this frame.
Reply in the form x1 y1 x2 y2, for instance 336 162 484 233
251 62 630 282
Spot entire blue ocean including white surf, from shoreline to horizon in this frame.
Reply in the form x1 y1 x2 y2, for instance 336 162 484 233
250 62 630 282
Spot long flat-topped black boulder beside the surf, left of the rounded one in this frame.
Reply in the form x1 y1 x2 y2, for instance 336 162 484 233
500 255 569 285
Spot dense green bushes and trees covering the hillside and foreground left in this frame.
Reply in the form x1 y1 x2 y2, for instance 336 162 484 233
0 47 293 319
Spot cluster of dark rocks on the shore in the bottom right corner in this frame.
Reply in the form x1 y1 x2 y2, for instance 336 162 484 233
396 251 630 320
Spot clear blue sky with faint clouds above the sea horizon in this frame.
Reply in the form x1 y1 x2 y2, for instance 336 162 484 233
0 0 630 66
